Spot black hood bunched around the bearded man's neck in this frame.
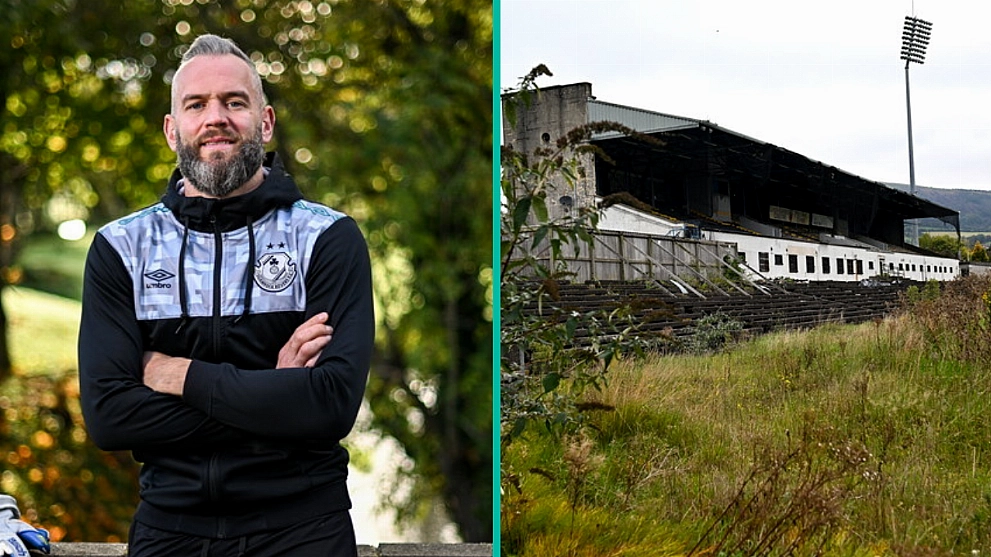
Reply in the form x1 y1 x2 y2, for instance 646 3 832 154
162 152 303 232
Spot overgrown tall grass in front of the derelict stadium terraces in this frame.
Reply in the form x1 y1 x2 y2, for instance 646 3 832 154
502 278 991 556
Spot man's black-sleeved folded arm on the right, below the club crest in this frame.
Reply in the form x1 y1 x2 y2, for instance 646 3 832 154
172 218 375 442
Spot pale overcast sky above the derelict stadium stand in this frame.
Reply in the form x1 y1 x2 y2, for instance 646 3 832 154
499 0 991 190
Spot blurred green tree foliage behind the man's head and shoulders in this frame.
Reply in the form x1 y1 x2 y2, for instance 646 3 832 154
0 0 493 541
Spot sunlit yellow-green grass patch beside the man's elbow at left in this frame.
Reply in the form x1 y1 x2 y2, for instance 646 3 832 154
2 286 80 376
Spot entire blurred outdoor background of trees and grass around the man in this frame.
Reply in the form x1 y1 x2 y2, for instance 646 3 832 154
0 0 493 544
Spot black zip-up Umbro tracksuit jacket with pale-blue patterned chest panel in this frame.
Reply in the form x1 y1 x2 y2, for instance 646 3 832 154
79 153 374 538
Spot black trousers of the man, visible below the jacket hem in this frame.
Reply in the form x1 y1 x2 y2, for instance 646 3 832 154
127 511 358 557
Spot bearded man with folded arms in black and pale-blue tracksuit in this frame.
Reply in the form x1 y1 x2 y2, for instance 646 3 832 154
78 35 374 557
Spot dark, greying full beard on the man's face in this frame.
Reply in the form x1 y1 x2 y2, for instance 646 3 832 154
176 125 265 197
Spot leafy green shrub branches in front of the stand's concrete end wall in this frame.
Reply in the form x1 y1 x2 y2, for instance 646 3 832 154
500 65 661 444
